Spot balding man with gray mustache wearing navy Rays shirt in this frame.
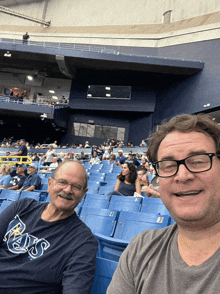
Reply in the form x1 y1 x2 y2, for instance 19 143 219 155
0 161 98 294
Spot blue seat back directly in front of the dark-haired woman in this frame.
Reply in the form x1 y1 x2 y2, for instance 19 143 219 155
109 195 143 212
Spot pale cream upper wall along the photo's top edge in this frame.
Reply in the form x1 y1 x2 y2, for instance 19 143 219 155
0 0 220 27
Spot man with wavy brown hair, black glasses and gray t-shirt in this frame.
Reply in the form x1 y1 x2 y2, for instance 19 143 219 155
107 114 220 294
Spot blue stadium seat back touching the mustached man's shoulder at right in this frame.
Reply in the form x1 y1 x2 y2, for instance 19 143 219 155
80 206 119 237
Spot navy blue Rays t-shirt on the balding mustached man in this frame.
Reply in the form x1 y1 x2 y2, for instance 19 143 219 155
0 198 98 294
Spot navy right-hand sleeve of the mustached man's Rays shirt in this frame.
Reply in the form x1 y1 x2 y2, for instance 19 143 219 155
62 235 98 294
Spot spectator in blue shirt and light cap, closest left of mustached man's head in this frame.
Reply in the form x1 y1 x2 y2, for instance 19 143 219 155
20 163 41 191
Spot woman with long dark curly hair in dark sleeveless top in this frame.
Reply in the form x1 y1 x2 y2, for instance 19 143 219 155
115 163 141 196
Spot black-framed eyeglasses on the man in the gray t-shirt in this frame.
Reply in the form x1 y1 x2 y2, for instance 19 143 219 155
153 153 219 178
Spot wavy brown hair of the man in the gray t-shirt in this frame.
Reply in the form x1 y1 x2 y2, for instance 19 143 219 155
147 113 220 162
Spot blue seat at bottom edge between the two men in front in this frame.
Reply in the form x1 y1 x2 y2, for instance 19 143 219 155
90 257 118 294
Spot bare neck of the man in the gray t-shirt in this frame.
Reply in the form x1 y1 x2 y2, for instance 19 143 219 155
177 223 220 266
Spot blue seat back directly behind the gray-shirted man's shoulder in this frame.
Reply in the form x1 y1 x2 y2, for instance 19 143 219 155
114 211 171 242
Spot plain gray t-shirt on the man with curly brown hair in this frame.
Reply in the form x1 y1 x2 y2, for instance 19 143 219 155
107 224 220 294
